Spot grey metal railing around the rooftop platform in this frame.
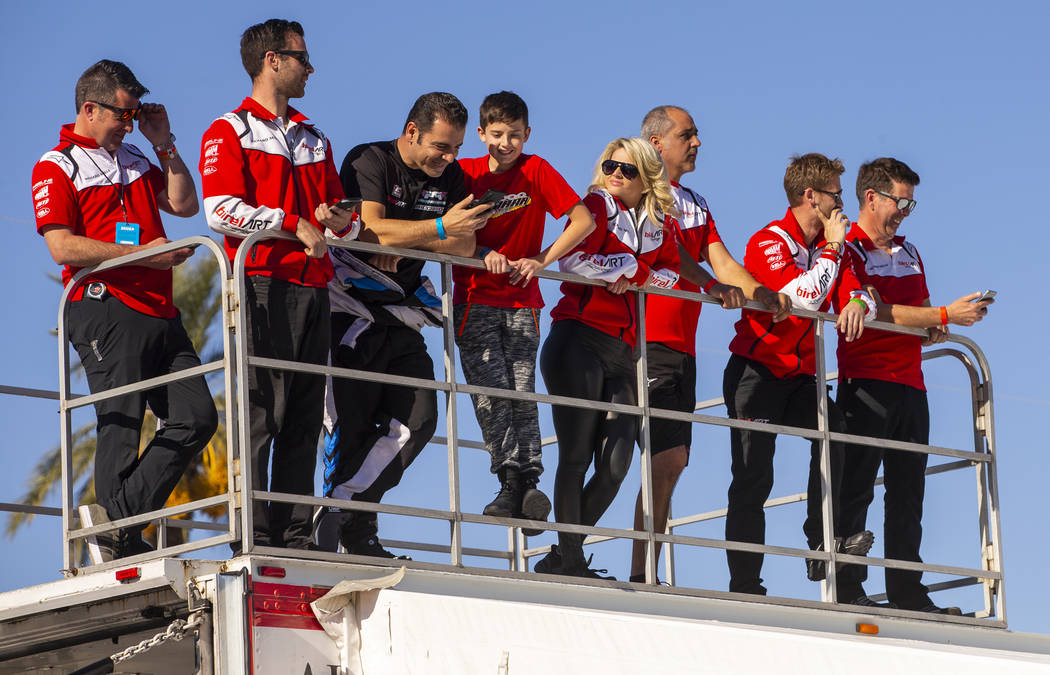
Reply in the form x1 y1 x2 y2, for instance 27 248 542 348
2 231 1006 627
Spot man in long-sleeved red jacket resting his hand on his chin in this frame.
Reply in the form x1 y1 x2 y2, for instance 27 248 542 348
722 152 877 595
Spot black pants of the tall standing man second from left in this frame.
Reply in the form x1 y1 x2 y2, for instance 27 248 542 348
246 275 331 548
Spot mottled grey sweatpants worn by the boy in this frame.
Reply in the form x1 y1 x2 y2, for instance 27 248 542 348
453 303 543 476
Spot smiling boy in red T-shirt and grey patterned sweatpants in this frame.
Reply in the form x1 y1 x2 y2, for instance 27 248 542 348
453 91 594 535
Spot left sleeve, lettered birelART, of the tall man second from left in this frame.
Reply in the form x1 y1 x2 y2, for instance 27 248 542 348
200 119 299 238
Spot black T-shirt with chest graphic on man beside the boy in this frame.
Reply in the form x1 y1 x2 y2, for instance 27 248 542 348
339 141 466 299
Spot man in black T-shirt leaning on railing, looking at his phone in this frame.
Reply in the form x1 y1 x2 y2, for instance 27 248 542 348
318 92 489 557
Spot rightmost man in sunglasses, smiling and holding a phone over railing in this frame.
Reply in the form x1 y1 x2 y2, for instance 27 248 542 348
836 157 990 614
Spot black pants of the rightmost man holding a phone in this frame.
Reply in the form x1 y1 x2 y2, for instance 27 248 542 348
838 378 930 609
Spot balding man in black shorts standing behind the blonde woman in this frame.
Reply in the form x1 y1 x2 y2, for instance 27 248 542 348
631 105 791 582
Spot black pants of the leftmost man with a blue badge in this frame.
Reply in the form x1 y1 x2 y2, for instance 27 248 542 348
69 295 218 529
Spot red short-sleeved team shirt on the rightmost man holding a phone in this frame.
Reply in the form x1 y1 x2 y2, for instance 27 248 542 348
835 223 929 392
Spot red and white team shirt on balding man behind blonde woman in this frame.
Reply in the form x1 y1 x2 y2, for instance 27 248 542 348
646 183 721 356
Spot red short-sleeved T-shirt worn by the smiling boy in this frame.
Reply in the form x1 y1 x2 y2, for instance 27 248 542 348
453 154 580 308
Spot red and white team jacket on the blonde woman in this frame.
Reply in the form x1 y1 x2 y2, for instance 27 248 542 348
550 190 679 347
